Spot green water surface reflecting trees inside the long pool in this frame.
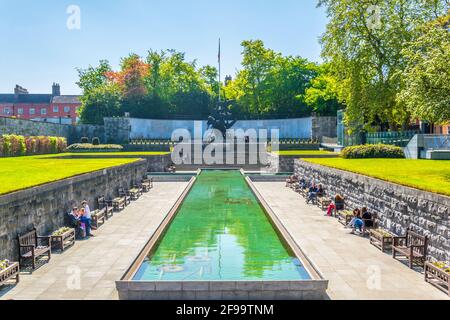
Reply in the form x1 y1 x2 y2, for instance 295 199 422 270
133 170 310 281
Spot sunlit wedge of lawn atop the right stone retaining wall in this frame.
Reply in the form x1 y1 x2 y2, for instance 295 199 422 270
303 158 450 196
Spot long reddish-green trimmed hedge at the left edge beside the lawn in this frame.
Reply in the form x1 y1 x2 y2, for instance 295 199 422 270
0 134 67 157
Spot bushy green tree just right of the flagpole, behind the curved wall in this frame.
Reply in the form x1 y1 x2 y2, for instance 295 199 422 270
224 40 316 116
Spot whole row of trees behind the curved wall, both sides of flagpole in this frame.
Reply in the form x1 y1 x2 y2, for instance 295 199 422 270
78 40 336 123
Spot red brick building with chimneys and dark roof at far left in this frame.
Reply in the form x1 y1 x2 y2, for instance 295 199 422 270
0 83 81 124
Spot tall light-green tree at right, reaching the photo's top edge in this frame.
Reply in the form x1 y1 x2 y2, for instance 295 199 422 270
319 0 445 129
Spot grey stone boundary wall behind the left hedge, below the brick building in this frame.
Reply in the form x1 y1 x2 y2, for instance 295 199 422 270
0 117 105 144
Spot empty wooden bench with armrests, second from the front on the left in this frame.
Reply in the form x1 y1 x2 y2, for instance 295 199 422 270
17 229 52 270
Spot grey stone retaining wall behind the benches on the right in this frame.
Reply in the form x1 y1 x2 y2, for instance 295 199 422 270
295 160 450 261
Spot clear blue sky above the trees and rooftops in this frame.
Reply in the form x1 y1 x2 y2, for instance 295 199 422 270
0 0 326 94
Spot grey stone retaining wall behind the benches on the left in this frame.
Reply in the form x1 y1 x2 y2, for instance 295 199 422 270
0 160 147 260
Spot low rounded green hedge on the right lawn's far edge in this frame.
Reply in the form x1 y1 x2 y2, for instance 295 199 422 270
341 144 405 159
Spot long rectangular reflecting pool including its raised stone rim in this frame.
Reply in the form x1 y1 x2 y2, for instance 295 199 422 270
116 170 328 300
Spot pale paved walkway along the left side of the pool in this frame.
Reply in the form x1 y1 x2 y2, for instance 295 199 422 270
0 182 187 300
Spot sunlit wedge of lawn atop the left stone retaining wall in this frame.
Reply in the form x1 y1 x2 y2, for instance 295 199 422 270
0 156 138 194
